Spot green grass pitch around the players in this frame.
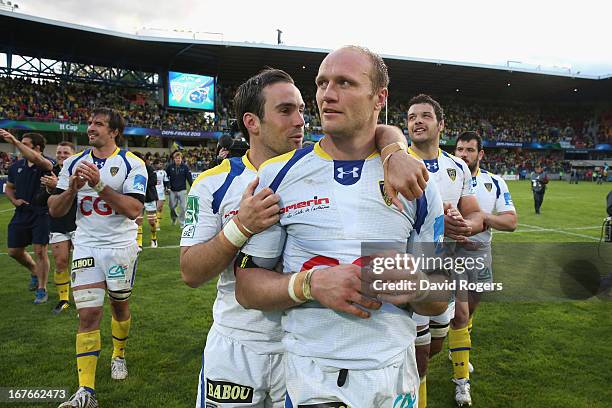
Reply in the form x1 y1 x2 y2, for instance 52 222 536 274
0 182 612 408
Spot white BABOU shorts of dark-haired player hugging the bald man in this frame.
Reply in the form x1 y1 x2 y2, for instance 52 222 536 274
196 326 285 408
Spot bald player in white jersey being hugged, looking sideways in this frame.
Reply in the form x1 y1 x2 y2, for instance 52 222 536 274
236 47 445 407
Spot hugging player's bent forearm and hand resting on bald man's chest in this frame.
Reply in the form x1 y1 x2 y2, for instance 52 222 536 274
180 178 280 288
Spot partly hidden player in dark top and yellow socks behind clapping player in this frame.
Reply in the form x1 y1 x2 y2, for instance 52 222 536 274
40 141 76 315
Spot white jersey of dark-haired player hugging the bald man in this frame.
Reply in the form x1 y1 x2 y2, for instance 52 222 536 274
181 155 284 354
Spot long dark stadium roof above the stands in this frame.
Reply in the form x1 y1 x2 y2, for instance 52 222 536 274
0 11 612 102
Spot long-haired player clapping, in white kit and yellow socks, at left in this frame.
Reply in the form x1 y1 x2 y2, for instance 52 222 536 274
49 108 147 408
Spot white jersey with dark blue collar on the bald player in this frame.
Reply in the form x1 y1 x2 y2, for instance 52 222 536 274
242 143 444 369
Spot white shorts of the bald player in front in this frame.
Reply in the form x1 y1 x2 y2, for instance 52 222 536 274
285 346 419 408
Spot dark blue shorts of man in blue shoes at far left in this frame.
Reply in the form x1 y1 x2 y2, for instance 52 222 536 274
7 211 49 248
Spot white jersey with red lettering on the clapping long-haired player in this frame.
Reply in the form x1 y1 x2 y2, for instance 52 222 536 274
57 148 147 248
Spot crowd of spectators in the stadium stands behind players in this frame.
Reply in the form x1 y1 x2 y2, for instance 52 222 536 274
0 78 612 178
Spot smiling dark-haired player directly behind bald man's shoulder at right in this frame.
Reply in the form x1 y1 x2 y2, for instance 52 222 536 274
408 94 483 407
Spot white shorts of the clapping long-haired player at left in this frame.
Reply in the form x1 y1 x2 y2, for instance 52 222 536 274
70 241 138 291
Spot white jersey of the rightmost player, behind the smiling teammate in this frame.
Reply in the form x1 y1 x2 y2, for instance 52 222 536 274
470 169 516 243
